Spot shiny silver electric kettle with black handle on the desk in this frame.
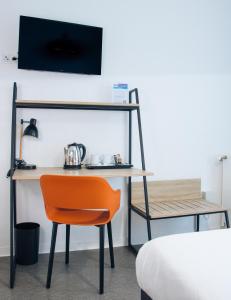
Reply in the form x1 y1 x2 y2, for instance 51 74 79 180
64 143 86 169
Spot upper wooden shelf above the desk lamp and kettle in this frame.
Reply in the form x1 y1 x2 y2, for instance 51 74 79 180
16 100 139 111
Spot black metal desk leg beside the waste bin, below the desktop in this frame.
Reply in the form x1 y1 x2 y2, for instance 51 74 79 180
10 179 16 289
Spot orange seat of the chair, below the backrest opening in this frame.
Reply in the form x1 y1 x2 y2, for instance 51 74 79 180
48 208 109 226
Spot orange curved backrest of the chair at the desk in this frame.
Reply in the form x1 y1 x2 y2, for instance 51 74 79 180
40 175 117 210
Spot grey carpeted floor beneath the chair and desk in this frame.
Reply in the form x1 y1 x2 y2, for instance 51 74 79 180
0 247 140 300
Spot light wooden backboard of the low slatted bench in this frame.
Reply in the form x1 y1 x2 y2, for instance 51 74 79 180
132 178 202 203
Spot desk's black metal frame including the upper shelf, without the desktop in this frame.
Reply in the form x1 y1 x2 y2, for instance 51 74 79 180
8 82 151 288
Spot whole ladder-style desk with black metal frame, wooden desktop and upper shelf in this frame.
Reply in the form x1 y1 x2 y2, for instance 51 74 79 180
8 82 153 288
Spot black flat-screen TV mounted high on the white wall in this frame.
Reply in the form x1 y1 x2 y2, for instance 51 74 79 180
18 16 103 75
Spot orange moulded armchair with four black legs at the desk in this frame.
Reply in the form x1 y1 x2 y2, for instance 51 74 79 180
40 175 120 294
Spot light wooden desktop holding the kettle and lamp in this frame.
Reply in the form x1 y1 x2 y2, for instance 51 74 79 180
12 167 153 180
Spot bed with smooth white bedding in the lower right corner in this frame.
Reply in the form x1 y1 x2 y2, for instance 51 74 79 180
136 229 231 300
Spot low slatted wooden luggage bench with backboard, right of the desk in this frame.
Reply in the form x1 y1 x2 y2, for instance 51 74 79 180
132 179 229 231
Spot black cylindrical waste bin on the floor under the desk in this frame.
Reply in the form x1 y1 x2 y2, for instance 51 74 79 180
15 222 40 265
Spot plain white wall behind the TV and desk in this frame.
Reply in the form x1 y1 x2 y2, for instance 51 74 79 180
0 0 231 255
